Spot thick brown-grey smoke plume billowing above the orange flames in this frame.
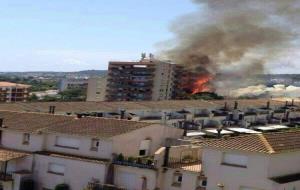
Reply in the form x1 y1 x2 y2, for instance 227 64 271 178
163 0 300 94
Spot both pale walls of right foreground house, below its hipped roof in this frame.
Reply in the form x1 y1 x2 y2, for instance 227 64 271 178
203 148 300 190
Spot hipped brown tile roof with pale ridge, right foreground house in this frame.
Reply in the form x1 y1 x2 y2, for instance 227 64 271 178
204 130 300 154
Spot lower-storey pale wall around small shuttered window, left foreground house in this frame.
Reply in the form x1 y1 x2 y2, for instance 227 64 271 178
34 155 107 190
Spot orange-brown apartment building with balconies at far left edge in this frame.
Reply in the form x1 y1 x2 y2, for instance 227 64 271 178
0 82 30 102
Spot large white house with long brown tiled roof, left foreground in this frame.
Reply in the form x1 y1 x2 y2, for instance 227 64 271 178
0 111 182 190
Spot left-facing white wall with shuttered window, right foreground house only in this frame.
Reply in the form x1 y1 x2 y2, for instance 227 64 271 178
202 148 273 190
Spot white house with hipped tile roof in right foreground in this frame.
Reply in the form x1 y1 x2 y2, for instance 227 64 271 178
202 130 300 190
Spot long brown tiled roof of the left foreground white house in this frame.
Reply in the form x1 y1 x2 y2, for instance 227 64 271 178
0 111 152 138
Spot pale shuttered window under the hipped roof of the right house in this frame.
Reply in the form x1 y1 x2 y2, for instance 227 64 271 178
222 153 248 168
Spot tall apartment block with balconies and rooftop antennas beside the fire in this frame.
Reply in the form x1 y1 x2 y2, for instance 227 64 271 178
106 55 175 101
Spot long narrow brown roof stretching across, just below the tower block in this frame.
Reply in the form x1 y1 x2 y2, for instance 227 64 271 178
0 99 292 113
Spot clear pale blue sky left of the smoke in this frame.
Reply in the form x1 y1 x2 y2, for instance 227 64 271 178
0 0 197 71
